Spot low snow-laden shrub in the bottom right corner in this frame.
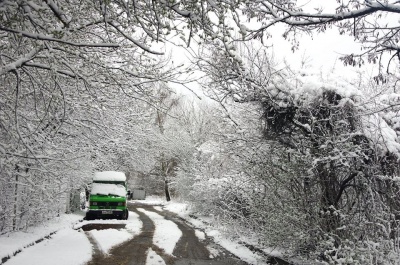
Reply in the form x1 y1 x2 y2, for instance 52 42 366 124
314 208 400 265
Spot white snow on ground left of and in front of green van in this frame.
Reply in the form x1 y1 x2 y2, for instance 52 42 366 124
0 209 143 265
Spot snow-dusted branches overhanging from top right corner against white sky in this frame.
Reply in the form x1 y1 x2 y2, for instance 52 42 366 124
237 0 400 73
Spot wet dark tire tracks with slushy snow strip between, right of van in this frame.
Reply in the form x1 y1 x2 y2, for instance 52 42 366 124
87 203 252 265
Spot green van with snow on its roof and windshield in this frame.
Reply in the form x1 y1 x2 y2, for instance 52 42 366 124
85 171 129 220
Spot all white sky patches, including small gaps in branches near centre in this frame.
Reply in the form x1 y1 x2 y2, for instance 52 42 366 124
164 0 386 97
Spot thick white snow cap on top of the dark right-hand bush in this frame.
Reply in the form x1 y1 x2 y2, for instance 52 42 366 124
277 70 400 158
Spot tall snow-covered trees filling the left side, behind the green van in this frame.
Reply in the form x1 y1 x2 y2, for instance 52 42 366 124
0 1 192 232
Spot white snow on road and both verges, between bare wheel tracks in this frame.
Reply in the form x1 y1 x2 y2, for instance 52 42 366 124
0 197 279 265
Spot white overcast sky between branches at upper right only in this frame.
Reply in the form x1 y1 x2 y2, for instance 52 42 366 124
253 0 400 78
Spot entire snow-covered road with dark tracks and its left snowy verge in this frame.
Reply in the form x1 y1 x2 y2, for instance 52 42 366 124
0 198 272 265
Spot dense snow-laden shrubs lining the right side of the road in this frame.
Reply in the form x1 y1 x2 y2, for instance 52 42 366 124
180 67 400 264
